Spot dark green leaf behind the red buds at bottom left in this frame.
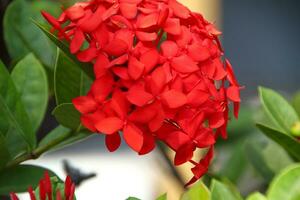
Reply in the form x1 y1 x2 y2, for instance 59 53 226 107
0 165 55 195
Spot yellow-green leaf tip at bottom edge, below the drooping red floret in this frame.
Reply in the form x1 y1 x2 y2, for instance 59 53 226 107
181 181 211 200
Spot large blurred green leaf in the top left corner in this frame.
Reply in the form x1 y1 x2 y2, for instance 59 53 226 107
3 0 55 68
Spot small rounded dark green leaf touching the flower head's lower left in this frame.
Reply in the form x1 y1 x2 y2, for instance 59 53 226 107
52 103 80 130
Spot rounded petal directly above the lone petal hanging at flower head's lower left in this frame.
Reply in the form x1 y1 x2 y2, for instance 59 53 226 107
95 117 124 135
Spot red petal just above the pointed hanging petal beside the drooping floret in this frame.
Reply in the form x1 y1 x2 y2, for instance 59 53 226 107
165 131 191 151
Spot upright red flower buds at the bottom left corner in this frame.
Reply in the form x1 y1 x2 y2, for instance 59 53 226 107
10 172 75 200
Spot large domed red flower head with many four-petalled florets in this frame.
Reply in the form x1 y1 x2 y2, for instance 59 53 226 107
43 0 240 183
